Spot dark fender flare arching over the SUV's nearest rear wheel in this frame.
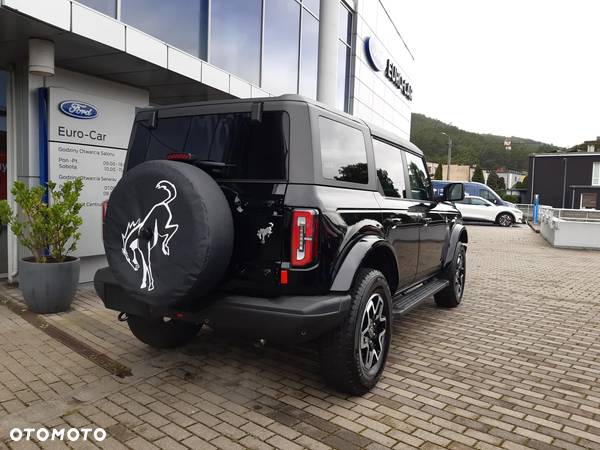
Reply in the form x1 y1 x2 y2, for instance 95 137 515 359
331 235 398 292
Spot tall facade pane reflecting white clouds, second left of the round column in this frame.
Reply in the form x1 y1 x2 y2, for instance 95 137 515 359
261 0 300 95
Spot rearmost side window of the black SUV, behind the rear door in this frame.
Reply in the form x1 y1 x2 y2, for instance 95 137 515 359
319 117 369 184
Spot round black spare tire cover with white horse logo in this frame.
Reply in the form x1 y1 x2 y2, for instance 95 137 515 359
104 160 234 307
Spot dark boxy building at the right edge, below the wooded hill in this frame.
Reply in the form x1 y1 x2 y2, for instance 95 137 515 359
527 152 600 209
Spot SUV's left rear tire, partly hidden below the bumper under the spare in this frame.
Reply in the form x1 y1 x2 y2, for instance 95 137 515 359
127 316 202 348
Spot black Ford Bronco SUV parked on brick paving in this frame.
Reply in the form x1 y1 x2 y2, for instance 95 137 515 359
95 95 467 394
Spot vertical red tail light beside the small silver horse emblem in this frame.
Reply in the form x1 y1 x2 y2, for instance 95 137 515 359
291 209 319 267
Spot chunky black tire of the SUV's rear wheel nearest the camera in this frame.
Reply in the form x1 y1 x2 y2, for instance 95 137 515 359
320 269 392 395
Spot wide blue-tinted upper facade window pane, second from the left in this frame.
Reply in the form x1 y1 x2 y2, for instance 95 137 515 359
121 0 209 59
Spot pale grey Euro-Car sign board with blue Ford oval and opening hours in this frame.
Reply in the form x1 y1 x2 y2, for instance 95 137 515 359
48 87 135 256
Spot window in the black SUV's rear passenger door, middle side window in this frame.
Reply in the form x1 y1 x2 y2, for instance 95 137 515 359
373 139 406 198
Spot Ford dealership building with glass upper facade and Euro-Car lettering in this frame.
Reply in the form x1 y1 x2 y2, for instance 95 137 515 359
0 0 414 281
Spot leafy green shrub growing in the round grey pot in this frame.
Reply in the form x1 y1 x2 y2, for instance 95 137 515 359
0 178 83 263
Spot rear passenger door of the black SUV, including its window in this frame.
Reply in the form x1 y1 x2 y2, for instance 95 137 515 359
373 139 422 289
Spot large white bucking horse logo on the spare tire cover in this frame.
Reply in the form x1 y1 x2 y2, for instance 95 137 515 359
121 180 179 291
